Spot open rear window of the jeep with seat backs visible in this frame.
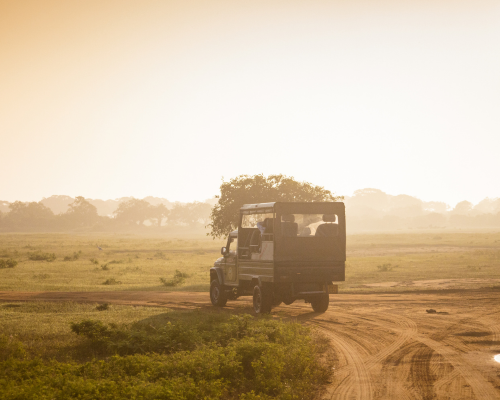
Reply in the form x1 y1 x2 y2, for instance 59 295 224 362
281 214 338 237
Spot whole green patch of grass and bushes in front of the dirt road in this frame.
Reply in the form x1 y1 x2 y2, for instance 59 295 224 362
0 303 332 400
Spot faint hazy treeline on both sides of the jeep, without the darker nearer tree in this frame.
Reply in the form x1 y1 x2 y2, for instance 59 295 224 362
0 188 500 233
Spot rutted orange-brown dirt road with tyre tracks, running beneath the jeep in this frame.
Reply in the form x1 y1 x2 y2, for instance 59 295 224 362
0 290 500 400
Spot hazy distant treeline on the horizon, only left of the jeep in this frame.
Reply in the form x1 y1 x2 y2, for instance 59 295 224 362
0 196 211 232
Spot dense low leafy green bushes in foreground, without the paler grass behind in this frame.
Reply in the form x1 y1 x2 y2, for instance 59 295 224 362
0 314 330 400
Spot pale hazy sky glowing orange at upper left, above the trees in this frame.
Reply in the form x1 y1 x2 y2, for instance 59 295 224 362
0 0 500 205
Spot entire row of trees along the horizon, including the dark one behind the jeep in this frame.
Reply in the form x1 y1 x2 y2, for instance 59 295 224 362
0 182 500 234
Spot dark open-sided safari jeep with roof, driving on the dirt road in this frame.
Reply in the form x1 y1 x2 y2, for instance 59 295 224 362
210 202 346 314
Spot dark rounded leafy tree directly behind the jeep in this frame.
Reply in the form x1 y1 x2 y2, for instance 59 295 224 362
208 174 342 238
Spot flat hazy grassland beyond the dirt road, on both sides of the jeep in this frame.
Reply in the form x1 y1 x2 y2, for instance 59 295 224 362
0 232 500 292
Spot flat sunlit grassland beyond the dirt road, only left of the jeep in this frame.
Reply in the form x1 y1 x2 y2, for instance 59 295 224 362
0 234 223 291
